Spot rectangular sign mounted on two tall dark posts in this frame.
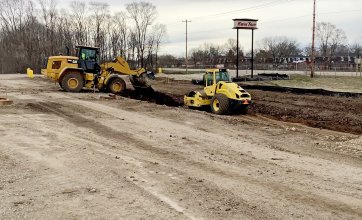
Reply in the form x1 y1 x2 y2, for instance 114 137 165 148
233 18 258 78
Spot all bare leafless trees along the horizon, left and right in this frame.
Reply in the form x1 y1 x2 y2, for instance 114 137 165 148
0 0 362 73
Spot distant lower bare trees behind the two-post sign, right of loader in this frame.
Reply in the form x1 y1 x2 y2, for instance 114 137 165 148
161 22 362 67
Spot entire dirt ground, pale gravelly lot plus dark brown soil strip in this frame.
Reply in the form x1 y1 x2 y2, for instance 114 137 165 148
0 75 362 219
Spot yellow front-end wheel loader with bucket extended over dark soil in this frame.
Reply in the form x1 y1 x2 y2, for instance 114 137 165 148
33 46 154 94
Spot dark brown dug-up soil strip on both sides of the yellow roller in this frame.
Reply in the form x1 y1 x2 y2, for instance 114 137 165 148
149 78 362 134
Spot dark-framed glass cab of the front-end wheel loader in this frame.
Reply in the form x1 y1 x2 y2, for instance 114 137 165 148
76 46 100 74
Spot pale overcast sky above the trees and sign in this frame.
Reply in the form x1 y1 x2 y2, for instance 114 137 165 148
59 0 362 56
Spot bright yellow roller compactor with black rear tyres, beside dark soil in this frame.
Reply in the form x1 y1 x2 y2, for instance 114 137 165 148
184 69 251 115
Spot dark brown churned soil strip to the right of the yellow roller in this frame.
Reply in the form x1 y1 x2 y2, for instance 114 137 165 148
249 90 362 134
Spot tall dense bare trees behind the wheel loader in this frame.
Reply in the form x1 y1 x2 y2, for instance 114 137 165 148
0 0 166 73
